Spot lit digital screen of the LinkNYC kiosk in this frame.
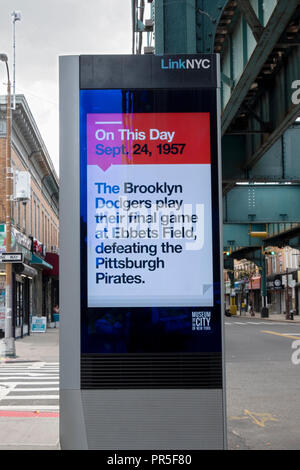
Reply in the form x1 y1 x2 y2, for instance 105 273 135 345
80 90 220 352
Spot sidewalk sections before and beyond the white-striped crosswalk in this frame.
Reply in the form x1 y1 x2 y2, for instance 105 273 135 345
0 328 60 450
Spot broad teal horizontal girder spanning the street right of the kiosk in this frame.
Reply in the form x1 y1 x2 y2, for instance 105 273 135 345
223 184 300 223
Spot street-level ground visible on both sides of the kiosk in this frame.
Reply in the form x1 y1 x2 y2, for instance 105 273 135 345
0 314 300 450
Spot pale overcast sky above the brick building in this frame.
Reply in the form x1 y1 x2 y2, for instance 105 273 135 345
0 0 132 174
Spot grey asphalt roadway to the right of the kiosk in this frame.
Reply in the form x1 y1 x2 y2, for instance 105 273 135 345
225 317 300 450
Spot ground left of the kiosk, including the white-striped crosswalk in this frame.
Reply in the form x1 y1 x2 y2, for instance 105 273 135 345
0 328 60 450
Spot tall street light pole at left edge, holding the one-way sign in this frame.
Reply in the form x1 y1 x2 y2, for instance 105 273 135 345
0 54 16 357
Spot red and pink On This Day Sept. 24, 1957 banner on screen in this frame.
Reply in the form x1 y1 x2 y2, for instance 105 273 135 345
87 113 210 171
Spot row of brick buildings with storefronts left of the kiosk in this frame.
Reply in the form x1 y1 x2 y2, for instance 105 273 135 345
0 95 59 338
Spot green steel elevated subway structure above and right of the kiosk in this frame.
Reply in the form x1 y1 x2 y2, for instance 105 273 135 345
132 0 300 315
